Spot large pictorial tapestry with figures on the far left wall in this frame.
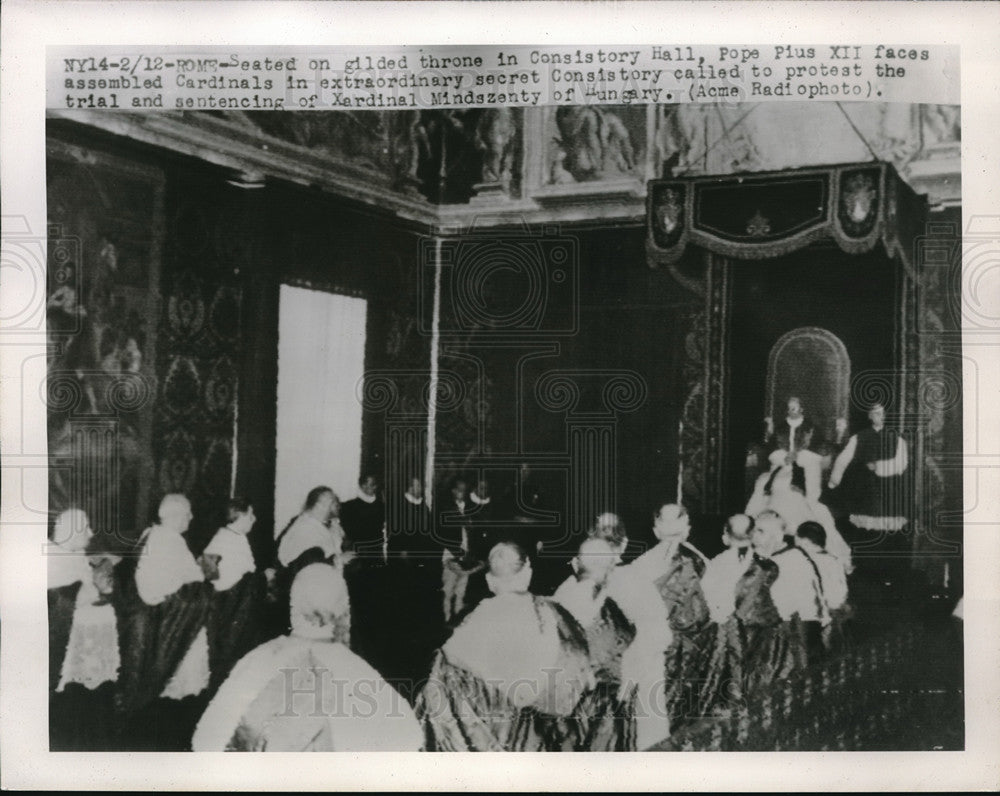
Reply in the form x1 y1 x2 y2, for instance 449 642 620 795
46 140 163 540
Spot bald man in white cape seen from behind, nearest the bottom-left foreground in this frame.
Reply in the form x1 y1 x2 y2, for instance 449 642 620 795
191 564 422 752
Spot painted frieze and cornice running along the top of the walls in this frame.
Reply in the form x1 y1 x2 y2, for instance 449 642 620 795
49 103 961 228
